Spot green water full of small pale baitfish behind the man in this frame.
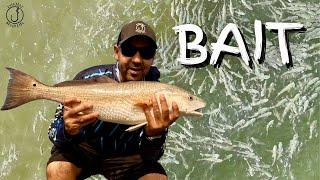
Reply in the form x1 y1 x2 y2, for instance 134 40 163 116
0 0 320 179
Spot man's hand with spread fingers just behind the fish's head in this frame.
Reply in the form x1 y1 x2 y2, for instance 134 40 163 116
143 95 180 136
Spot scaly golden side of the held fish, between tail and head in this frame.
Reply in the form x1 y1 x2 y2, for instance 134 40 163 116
44 82 178 125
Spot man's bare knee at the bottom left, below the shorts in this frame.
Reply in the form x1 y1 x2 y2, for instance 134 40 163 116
47 161 81 180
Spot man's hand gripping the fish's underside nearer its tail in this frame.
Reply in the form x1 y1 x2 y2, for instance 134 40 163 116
63 98 98 135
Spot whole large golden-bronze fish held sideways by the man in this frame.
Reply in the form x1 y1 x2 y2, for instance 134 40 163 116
1 68 205 125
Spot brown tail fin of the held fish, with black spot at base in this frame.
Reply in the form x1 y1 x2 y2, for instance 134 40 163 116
1 67 43 110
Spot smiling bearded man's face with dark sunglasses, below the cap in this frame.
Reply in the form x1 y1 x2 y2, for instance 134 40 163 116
114 36 154 82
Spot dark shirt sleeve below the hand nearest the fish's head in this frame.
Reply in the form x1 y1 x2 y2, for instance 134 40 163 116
140 129 168 161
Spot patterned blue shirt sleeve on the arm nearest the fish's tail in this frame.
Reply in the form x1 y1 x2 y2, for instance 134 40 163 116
48 104 80 146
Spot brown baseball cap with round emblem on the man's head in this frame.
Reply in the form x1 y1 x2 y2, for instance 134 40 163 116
117 21 157 48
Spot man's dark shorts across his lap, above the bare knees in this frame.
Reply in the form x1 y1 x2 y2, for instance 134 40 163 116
47 146 166 180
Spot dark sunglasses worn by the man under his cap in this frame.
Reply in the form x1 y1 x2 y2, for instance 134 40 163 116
120 43 156 59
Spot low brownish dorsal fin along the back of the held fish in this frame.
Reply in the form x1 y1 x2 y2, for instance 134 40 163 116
53 76 118 87
